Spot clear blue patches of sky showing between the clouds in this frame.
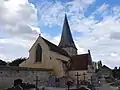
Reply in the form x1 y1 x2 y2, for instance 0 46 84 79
29 0 120 36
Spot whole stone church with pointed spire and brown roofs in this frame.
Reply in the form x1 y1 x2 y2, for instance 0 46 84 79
19 15 95 80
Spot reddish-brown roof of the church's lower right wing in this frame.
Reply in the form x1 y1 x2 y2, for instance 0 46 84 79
71 53 92 70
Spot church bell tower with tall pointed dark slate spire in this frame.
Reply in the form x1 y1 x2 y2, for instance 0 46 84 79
58 14 77 56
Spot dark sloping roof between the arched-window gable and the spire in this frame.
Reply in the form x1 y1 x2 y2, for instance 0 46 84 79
42 37 70 57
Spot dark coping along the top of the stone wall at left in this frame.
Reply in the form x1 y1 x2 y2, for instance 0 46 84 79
0 66 53 71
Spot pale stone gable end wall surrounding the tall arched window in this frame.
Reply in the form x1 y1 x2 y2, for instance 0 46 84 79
19 36 51 69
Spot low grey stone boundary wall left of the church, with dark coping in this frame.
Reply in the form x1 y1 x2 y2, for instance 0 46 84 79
0 66 52 88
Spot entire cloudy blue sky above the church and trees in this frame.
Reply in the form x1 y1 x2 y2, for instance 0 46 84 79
0 0 120 67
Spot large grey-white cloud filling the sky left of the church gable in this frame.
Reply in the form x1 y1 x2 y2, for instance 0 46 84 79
0 0 39 60
